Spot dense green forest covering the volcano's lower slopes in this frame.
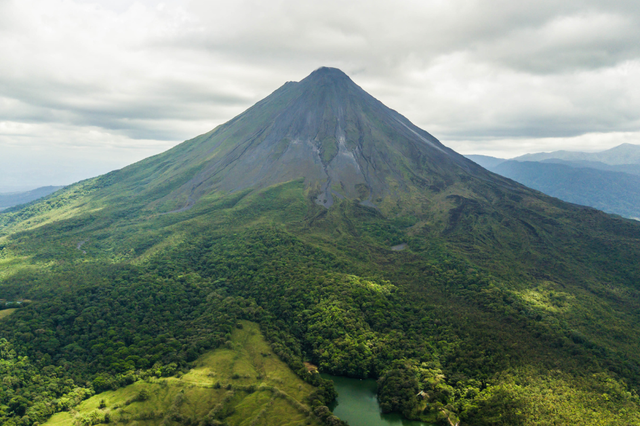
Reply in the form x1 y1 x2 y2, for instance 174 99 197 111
0 176 640 426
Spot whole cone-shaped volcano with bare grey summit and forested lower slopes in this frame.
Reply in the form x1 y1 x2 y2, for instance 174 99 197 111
0 68 640 425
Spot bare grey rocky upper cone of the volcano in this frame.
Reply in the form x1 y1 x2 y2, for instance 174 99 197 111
111 67 513 215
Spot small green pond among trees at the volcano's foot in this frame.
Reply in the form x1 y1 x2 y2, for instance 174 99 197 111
322 374 430 426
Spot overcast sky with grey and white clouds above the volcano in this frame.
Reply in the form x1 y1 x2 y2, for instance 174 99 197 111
0 0 640 192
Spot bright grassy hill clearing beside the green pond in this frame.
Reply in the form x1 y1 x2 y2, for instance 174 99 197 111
46 321 320 426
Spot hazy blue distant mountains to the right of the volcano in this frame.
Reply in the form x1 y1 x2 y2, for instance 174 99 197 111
467 144 640 219
